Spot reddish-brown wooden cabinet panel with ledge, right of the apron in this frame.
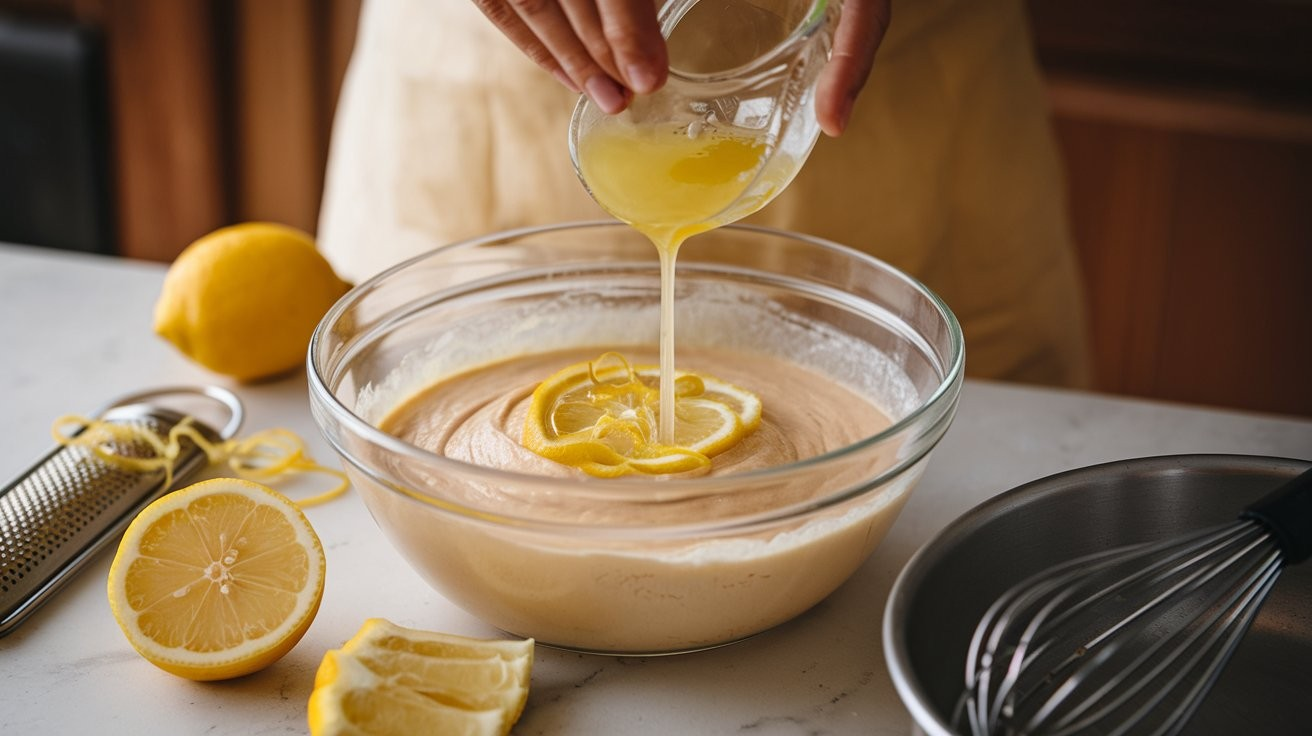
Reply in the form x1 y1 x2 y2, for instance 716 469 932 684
1051 79 1312 416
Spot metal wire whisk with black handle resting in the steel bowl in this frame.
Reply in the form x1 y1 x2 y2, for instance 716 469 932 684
954 471 1312 736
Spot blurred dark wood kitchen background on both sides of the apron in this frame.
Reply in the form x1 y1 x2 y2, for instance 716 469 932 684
0 0 1312 416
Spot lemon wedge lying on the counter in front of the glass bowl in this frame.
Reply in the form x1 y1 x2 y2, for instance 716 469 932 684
307 618 533 736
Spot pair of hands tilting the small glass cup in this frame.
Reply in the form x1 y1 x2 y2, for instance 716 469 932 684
474 0 891 136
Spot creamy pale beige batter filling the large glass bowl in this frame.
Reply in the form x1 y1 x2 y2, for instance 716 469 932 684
348 346 921 653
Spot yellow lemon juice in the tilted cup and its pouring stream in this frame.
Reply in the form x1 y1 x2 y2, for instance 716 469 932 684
579 119 774 445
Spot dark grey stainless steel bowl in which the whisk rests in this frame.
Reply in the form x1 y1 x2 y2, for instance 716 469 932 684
883 455 1312 736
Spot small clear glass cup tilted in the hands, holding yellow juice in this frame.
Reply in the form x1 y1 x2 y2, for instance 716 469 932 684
569 0 838 232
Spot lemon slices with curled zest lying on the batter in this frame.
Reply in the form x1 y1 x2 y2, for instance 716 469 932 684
522 353 761 478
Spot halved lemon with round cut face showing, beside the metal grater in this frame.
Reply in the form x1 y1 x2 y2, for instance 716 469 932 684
108 478 324 680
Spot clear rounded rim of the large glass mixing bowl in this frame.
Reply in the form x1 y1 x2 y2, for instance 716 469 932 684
306 220 966 502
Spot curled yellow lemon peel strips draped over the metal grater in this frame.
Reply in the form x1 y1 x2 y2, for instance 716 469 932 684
51 415 350 509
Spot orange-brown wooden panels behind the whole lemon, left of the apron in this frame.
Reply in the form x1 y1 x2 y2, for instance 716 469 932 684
0 0 361 261
